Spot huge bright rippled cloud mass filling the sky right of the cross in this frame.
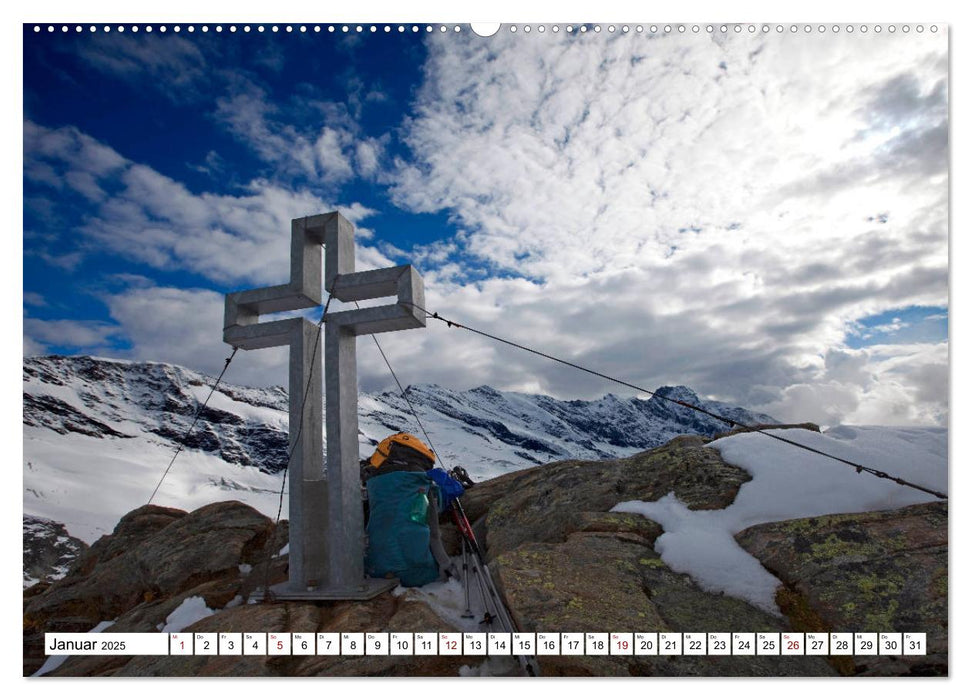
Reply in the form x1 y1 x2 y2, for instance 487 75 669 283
372 28 948 423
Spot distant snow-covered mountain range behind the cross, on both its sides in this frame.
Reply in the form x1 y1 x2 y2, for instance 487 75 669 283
24 356 775 543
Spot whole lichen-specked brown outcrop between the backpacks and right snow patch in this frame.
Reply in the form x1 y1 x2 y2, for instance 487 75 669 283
454 436 835 676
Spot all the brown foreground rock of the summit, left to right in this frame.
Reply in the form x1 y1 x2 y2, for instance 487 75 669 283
24 437 948 676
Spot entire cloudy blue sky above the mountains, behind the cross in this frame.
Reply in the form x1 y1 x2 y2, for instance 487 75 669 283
23 24 949 424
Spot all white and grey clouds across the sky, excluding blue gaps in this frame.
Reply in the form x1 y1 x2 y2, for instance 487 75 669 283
25 33 948 424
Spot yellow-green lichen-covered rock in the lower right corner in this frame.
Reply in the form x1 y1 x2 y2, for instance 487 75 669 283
736 502 948 675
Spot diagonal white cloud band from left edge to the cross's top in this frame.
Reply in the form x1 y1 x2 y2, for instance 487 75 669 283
24 122 391 284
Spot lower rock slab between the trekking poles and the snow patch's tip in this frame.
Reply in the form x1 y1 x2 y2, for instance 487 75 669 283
494 532 835 676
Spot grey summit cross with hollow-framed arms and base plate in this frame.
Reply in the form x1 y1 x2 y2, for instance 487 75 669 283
223 211 425 600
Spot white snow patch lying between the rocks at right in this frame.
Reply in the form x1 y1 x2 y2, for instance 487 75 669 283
613 426 948 615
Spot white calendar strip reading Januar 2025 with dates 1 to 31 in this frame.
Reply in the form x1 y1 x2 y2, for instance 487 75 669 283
45 632 927 656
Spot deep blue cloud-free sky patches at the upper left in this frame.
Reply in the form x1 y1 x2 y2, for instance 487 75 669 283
24 25 440 308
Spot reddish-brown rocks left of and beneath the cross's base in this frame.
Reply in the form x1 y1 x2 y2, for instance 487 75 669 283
24 501 474 676
